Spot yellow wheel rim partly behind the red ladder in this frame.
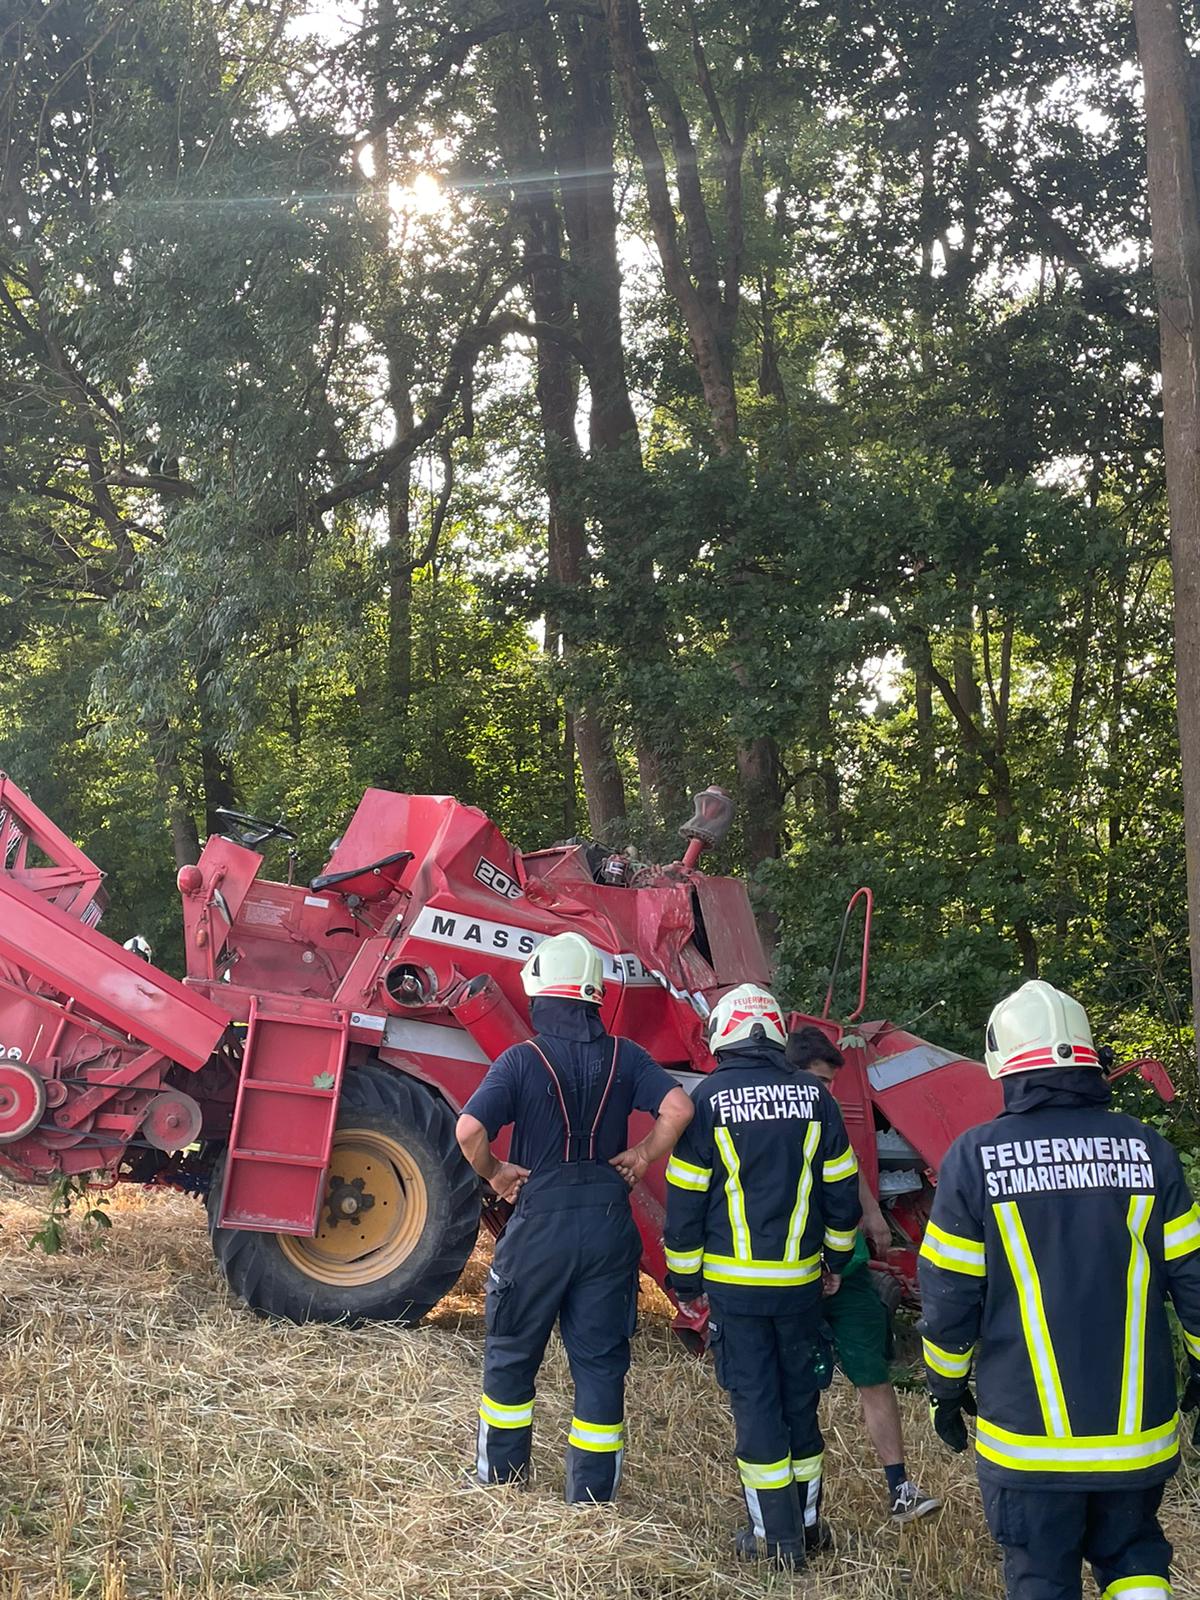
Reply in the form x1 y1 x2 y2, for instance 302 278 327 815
277 1128 429 1288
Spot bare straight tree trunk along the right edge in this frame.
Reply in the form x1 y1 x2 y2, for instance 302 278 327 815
1133 0 1200 1062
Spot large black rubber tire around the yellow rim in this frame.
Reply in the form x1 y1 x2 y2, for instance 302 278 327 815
208 1064 480 1328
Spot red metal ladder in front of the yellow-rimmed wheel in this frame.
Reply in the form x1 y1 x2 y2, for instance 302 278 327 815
219 1000 350 1235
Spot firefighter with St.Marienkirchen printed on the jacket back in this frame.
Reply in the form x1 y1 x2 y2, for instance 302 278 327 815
920 981 1200 1600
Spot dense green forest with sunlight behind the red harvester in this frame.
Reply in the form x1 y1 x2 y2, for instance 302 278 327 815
0 0 1190 1064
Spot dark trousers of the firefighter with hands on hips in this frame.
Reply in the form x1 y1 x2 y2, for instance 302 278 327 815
478 1162 642 1501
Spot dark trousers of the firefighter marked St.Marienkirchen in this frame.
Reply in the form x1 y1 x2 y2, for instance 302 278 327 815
979 1478 1171 1600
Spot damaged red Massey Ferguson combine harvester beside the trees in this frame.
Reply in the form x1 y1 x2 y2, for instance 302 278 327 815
0 774 1162 1322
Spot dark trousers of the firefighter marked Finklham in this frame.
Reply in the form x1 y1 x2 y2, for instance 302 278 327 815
709 1296 824 1554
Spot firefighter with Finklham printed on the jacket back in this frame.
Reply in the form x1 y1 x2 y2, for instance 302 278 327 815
664 984 862 1566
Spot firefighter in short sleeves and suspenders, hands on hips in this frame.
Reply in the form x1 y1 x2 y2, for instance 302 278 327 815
458 933 691 1501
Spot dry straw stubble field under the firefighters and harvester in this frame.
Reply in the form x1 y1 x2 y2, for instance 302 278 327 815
0 1187 1200 1600
